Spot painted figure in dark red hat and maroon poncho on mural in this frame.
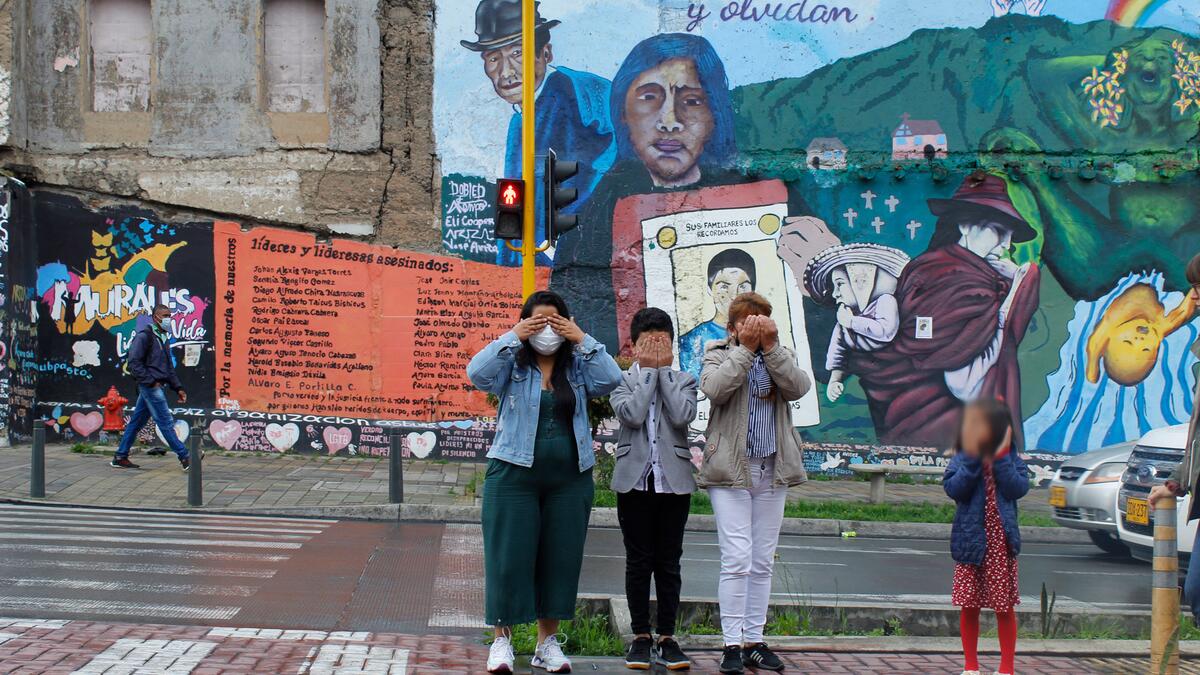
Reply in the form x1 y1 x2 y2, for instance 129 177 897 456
845 172 1039 448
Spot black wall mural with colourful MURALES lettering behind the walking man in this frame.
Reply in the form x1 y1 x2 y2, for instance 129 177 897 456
34 193 214 406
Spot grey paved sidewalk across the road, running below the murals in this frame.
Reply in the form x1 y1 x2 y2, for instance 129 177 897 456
0 444 1050 514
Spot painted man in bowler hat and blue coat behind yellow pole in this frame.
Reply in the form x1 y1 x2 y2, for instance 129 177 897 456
461 0 617 265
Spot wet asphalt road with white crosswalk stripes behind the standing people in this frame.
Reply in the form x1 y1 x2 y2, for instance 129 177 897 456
0 504 1150 634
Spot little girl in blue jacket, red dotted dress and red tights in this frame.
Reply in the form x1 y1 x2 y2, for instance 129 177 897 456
942 400 1030 675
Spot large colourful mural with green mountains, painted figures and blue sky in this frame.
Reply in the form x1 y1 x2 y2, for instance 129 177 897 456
434 0 1200 454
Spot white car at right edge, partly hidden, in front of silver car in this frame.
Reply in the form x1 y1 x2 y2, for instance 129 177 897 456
1117 424 1196 559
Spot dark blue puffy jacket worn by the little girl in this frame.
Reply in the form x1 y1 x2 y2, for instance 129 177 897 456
942 452 1030 565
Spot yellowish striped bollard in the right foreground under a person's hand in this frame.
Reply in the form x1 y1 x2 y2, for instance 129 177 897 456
1150 498 1180 675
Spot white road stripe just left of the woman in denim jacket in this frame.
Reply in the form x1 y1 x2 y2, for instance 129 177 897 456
428 524 487 628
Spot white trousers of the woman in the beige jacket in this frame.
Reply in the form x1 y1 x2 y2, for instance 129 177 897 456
708 456 787 645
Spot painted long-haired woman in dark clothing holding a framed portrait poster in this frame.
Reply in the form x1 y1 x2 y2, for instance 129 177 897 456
551 34 838 372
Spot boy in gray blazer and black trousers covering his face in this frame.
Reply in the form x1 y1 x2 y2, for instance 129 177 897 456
610 307 697 670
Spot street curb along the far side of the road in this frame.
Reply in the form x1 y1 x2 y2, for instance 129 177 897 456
0 497 1091 544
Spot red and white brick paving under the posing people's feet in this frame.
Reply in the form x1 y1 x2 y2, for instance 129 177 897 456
0 619 1200 675
